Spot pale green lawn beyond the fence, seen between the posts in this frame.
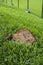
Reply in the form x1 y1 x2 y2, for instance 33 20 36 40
0 0 42 16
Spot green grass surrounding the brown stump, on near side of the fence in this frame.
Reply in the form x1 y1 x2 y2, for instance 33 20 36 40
0 0 43 65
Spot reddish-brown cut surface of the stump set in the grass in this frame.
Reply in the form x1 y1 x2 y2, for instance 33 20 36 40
12 29 35 43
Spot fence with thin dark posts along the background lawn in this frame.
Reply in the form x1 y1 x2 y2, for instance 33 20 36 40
0 0 42 16
